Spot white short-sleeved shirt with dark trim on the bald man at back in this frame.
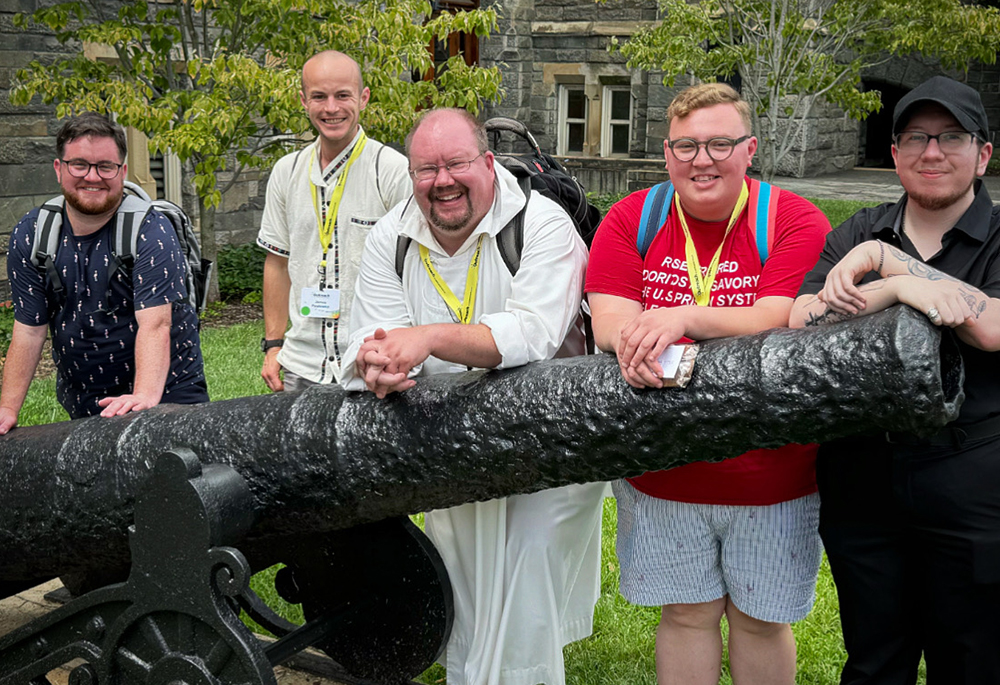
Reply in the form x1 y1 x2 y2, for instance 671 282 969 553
257 128 413 383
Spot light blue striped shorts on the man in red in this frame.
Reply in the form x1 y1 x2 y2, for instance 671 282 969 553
613 480 822 623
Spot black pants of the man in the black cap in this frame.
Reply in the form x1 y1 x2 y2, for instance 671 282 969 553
817 439 1000 685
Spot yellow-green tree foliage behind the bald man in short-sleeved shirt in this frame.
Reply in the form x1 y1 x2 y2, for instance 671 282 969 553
11 0 501 208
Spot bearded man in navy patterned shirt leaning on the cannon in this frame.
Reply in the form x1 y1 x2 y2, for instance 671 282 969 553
0 113 208 435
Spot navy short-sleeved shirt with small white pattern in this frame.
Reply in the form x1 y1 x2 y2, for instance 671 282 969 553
7 209 208 418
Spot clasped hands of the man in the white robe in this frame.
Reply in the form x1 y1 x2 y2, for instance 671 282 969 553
355 328 431 399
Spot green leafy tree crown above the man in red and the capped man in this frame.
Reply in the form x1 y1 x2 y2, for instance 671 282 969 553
609 0 1000 175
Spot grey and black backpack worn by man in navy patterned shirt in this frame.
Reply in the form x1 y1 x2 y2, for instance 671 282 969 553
31 181 212 314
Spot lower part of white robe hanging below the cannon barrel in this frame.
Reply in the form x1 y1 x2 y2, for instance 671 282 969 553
425 483 605 685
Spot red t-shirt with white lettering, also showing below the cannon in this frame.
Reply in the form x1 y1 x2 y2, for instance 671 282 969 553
586 179 830 505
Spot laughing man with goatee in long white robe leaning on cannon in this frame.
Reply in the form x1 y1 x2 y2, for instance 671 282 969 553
344 110 604 685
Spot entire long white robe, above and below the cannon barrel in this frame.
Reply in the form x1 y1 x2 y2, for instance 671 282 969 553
343 164 605 685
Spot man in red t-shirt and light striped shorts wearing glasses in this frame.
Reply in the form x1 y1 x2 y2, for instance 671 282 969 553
586 84 830 685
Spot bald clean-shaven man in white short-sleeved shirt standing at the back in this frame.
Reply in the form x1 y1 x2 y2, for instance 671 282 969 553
257 50 412 392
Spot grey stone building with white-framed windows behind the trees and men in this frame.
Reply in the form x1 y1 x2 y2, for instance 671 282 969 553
0 0 1000 301
